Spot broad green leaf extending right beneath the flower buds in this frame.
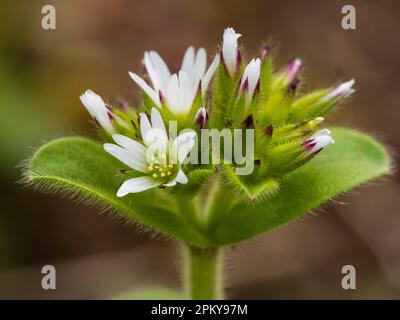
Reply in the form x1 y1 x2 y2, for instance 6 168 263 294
210 128 391 245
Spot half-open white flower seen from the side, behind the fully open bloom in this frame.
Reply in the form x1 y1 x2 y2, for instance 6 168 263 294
129 47 219 114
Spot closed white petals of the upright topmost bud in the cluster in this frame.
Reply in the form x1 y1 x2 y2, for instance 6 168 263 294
222 28 241 77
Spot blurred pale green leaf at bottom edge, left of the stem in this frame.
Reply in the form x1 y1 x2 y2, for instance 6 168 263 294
111 288 183 300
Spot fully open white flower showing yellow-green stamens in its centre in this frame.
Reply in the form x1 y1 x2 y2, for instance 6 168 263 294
104 108 196 197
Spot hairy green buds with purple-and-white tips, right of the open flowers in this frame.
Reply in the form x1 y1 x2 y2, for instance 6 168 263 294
214 29 354 190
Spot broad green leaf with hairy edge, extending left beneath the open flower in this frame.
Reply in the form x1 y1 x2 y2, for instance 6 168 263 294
26 137 207 245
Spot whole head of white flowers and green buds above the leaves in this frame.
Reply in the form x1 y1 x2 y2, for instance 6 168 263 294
81 28 354 196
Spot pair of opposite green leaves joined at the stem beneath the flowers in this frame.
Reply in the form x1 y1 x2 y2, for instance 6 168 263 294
26 128 390 247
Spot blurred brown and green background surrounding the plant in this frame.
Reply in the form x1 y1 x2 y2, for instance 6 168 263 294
0 0 400 299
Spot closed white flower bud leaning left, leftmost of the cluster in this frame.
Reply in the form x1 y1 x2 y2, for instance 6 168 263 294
79 90 115 133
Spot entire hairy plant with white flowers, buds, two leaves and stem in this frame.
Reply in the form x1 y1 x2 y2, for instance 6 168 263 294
25 28 390 299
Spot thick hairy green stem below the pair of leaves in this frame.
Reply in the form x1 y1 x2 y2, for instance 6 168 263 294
183 246 223 300
